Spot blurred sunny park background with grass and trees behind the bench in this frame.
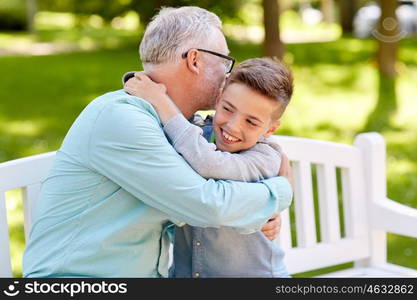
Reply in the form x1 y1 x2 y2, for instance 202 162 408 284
0 0 417 277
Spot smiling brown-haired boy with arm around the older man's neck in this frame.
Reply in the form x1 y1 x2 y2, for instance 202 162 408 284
125 58 293 277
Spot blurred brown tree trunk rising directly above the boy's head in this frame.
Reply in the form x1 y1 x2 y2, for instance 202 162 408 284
262 0 284 59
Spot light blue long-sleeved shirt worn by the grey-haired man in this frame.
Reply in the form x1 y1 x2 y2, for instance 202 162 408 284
23 90 291 277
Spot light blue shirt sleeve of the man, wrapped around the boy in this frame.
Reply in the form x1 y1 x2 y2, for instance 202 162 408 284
89 97 292 233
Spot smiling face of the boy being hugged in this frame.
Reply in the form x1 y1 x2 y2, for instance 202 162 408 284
213 83 280 152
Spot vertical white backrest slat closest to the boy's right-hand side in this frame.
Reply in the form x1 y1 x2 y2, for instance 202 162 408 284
293 161 317 247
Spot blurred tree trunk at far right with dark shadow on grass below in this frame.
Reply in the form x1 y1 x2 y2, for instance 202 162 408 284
365 0 401 131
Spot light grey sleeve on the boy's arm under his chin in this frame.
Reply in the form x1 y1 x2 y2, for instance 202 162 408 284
164 114 281 181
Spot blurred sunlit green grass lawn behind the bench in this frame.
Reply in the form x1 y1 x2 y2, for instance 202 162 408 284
0 36 417 276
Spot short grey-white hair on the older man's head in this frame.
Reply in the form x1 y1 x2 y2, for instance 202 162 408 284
139 6 222 65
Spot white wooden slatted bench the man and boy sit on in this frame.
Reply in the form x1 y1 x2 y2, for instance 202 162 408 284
0 133 417 277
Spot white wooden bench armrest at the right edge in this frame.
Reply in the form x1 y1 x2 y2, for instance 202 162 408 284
370 198 417 238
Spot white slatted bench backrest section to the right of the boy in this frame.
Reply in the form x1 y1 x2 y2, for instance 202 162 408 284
276 136 370 274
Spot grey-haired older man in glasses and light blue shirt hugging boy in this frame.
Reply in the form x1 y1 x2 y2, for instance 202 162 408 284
23 7 292 277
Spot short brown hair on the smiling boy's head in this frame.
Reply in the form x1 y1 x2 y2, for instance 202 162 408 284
226 57 294 119
